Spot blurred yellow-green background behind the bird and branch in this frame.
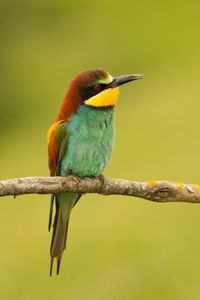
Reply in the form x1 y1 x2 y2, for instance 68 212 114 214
0 0 200 300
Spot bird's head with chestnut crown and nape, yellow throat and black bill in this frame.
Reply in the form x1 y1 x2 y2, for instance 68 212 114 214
57 69 143 120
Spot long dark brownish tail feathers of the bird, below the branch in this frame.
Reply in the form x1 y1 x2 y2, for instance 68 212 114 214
50 204 69 276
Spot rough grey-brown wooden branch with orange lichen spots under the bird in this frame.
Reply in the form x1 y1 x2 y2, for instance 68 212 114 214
0 177 200 203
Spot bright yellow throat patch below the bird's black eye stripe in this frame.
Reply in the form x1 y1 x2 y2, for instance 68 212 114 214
85 87 119 107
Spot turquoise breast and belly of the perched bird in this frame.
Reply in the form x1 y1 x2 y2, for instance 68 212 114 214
61 105 115 177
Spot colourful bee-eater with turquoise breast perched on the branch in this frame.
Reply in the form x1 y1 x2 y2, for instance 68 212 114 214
47 69 143 276
